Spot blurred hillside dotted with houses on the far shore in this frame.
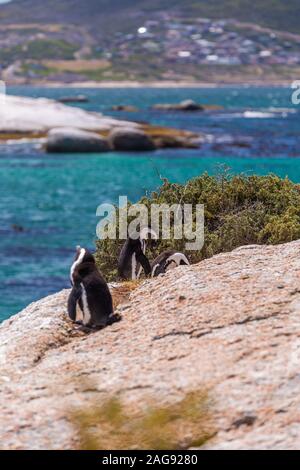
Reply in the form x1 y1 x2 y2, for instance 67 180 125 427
0 0 300 83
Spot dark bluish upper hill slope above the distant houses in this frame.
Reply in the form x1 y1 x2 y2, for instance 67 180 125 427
0 0 300 33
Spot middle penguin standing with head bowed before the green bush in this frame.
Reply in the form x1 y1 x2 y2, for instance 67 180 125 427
118 227 157 280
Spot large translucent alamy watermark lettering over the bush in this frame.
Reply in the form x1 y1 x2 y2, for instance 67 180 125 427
96 196 204 251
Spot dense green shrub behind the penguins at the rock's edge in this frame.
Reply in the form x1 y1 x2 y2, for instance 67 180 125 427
96 172 300 280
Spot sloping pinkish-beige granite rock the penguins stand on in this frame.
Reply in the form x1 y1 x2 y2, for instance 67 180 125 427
0 241 300 449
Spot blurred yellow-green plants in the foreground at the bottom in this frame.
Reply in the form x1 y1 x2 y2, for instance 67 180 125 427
71 391 213 450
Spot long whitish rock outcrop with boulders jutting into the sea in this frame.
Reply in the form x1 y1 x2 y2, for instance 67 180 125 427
0 96 201 152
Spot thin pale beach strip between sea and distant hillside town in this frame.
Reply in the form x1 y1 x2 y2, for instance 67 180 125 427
7 80 291 89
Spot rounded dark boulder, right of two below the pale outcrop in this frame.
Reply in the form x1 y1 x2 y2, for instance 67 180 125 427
108 127 156 152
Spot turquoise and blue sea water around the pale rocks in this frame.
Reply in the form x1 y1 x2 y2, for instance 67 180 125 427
0 87 300 321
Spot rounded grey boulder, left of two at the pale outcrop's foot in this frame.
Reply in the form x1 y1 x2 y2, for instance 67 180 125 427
46 127 109 153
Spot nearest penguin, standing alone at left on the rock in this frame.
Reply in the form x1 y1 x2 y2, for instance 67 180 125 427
68 247 113 328
